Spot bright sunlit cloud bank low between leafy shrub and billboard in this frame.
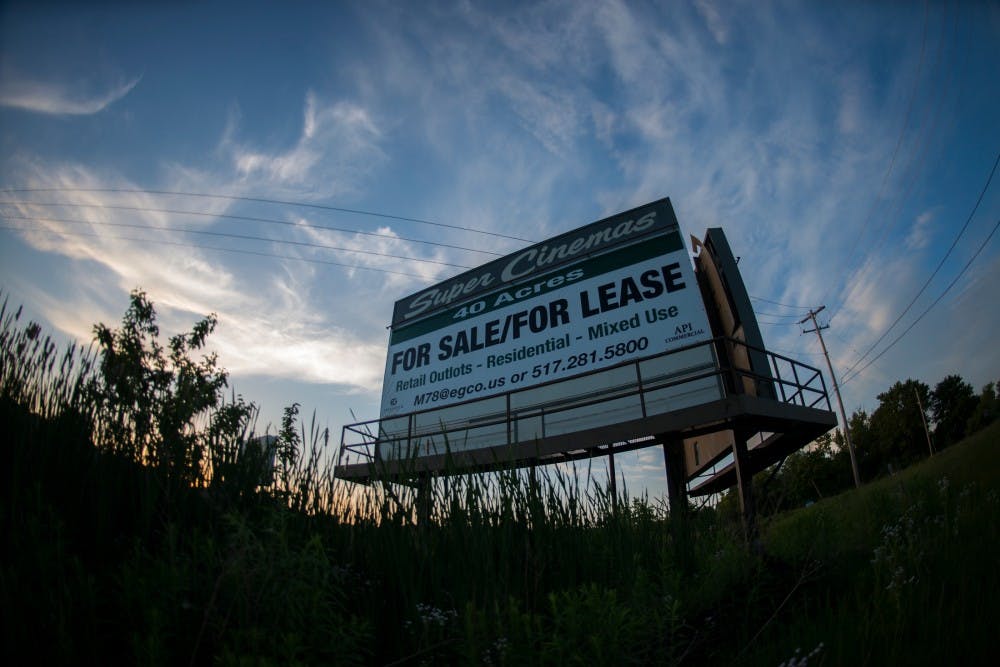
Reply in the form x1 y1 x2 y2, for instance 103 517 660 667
7 170 396 391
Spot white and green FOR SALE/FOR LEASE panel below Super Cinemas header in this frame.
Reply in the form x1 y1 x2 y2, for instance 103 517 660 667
382 219 711 419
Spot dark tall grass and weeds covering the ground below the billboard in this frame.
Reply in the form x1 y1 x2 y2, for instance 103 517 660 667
0 294 998 665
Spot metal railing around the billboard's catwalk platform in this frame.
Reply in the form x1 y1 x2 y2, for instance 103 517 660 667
338 338 831 465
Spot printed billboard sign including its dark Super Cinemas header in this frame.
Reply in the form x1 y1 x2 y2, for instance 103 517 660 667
380 198 714 448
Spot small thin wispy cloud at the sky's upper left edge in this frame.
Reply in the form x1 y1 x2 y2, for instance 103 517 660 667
0 76 142 116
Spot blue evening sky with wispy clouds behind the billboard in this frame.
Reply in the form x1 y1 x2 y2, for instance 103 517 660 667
0 0 1000 496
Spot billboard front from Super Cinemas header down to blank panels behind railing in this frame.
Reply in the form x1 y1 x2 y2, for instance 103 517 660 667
380 199 721 458
